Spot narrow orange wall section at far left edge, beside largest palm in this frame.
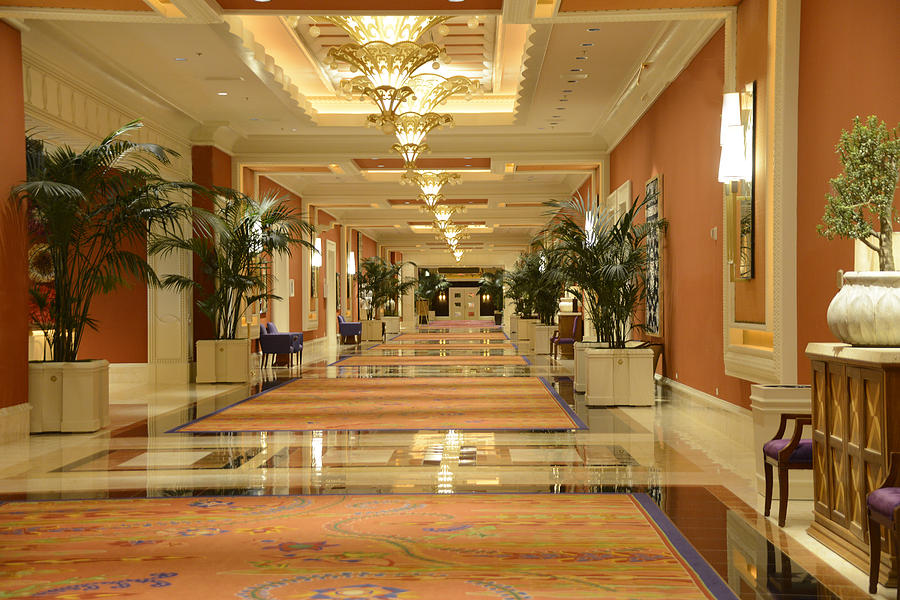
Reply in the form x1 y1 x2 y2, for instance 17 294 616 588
0 23 29 408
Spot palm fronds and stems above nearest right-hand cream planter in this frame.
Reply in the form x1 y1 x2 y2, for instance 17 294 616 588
543 199 666 348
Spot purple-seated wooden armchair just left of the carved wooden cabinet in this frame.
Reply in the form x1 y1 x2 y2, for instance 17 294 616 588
763 413 812 527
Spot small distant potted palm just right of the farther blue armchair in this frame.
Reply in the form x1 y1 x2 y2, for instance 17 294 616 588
357 256 417 341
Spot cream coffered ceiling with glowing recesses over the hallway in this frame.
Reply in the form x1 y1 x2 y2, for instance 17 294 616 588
0 0 737 264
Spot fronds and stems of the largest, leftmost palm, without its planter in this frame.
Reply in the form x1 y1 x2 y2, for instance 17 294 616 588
11 121 202 362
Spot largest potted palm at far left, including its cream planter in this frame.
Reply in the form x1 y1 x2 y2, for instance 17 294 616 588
11 121 201 432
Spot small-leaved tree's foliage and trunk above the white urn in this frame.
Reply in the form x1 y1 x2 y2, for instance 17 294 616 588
819 115 900 271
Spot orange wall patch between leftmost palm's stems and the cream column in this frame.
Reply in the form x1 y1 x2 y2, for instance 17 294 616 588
78 240 147 363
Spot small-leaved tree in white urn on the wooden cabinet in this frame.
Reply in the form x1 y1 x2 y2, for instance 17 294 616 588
819 115 900 347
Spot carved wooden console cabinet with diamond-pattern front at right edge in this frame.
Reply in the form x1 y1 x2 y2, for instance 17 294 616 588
806 343 900 585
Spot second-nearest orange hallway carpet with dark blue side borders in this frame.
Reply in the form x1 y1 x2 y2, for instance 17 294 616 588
170 377 585 433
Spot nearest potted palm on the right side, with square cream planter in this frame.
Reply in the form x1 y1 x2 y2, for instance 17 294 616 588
544 195 666 406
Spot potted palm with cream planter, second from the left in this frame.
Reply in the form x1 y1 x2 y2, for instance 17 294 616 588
150 188 315 383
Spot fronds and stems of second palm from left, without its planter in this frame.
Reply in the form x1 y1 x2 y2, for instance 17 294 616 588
150 188 315 339
